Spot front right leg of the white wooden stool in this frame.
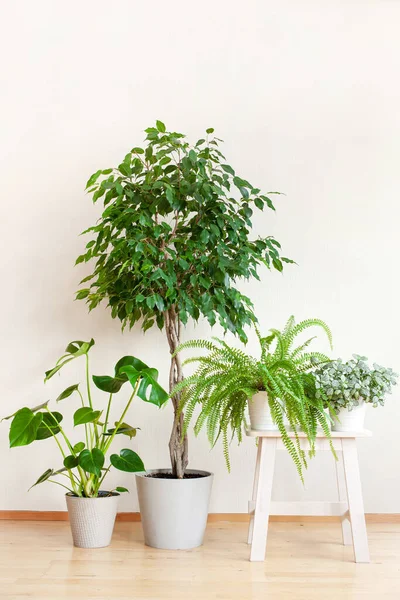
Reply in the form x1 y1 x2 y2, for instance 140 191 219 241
342 438 369 563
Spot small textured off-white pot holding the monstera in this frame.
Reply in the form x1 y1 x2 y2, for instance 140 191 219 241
65 493 119 548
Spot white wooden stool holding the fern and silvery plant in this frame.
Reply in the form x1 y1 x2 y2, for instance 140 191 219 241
246 429 372 563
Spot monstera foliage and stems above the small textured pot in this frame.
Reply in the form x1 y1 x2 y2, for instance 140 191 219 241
1 339 168 498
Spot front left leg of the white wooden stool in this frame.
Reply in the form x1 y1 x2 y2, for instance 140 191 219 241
250 437 276 561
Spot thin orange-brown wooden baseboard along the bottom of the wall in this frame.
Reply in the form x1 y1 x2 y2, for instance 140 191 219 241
0 510 400 523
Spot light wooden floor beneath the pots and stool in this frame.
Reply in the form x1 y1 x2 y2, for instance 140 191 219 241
0 521 400 600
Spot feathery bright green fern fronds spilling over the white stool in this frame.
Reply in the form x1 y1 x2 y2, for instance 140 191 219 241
174 317 332 480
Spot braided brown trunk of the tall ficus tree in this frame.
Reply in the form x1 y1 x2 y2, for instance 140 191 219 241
164 308 189 479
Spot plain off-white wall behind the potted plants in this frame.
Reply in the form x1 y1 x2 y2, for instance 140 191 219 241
0 0 400 512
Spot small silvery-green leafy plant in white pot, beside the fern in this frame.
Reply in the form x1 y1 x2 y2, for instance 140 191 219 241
314 354 398 431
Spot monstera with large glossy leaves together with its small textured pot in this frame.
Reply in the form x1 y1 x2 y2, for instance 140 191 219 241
2 339 168 548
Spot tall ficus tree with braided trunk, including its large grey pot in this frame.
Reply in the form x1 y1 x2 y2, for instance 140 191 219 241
76 121 292 548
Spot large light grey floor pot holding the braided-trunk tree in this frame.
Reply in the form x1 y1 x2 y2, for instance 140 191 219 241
136 469 213 550
